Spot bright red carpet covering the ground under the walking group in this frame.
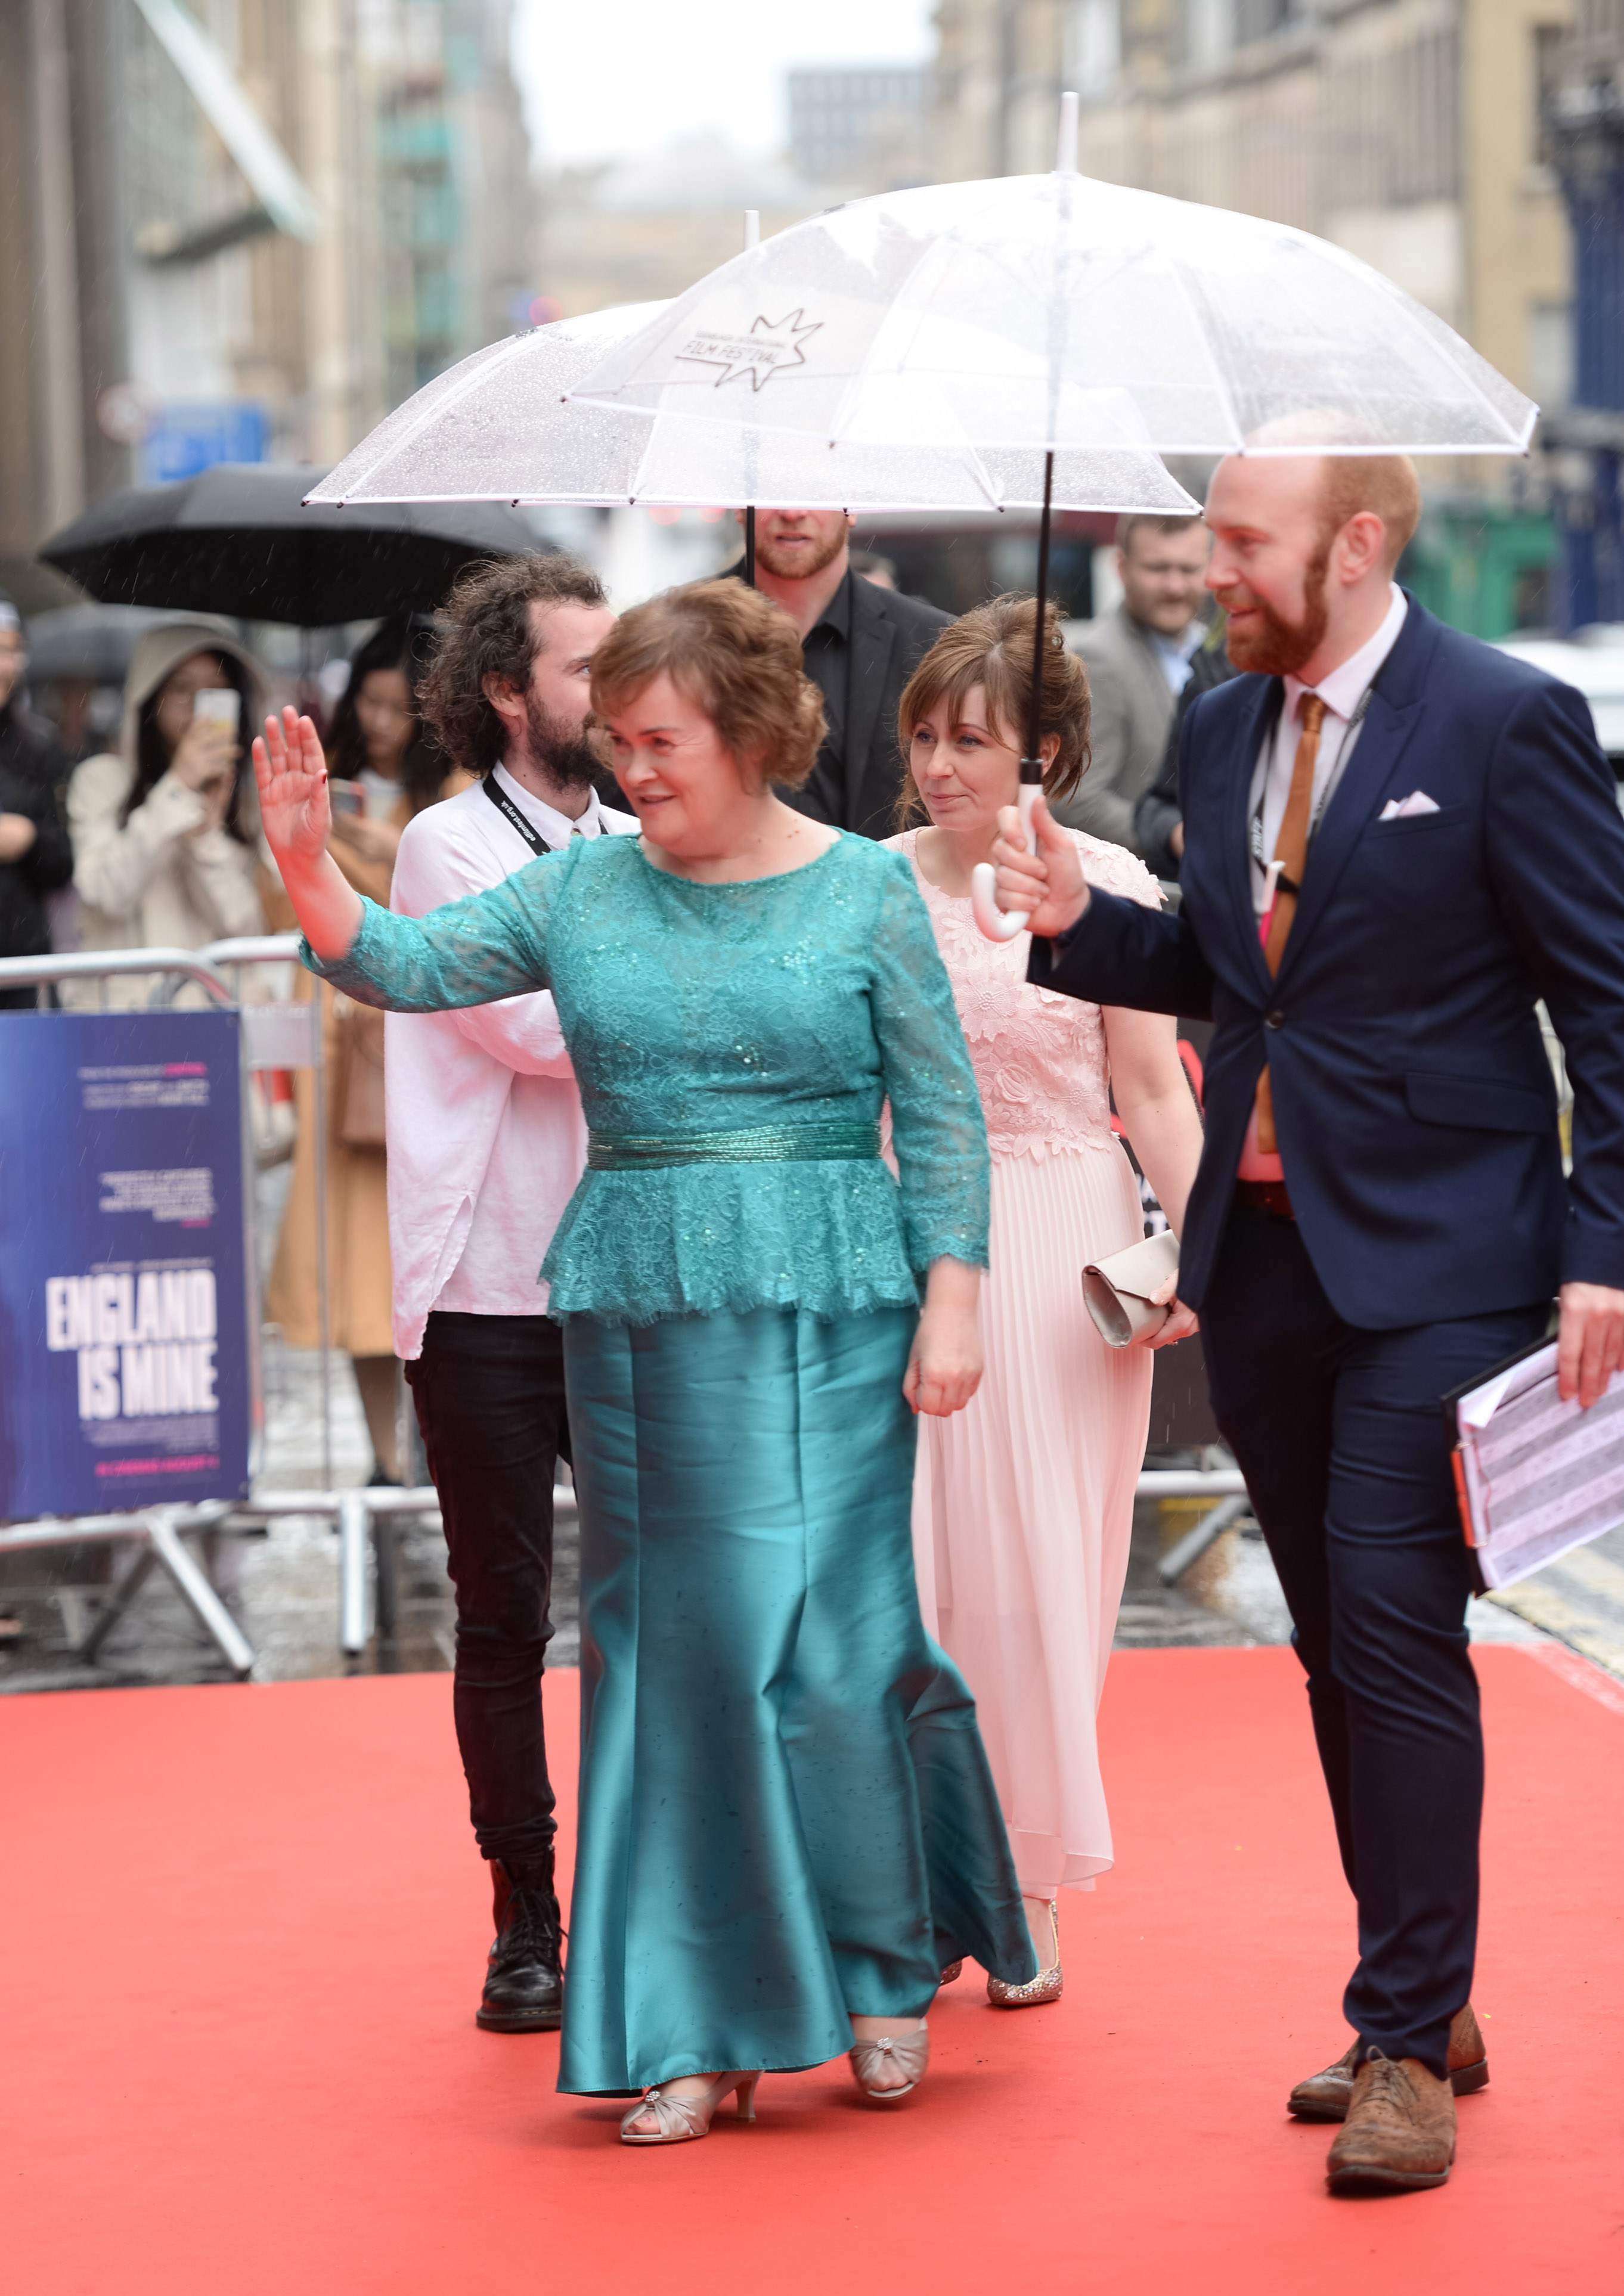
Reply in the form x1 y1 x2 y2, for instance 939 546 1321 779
0 1649 1624 2296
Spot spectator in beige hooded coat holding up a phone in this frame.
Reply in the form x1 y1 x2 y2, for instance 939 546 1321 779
62 618 269 1006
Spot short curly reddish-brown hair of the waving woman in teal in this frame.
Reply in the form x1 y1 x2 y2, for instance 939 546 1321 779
593 576 825 790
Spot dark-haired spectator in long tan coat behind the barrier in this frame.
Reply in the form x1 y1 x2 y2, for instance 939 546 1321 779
264 615 464 1483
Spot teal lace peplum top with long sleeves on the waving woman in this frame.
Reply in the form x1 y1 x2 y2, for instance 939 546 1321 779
305 836 988 1323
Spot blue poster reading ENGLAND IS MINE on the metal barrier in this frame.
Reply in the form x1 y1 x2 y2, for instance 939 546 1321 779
0 1010 250 1520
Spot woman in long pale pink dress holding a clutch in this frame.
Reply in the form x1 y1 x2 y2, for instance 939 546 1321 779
891 597 1201 2007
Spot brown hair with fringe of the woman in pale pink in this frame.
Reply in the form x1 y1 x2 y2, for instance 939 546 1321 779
896 595 1091 829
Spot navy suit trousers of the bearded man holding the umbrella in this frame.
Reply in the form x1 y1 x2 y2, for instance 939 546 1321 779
1201 1205 1548 2078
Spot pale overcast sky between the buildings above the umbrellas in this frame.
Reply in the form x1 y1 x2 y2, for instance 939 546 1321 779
512 0 935 167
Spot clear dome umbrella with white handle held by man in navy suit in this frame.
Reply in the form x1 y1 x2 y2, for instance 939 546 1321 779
577 97 1537 939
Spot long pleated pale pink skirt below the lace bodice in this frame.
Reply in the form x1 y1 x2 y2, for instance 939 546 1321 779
914 1143 1151 1897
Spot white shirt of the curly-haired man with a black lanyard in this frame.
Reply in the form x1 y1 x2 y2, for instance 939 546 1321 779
383 765 639 1361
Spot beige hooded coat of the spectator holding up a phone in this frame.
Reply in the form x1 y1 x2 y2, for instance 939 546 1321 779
64 620 269 1008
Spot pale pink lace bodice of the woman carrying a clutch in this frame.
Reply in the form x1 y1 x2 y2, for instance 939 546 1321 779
887 829 1163 1157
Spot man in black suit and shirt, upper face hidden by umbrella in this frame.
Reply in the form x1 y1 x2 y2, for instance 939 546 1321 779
734 510 953 838
